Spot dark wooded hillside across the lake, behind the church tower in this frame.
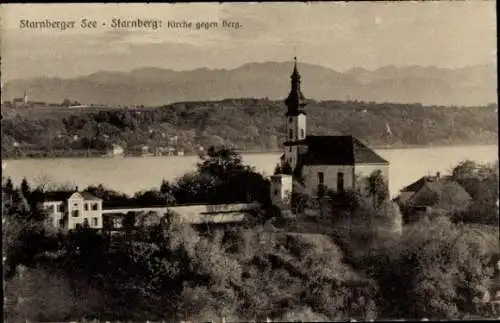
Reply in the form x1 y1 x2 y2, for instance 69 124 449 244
2 99 498 158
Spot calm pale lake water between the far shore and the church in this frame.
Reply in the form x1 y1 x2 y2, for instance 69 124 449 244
2 145 498 196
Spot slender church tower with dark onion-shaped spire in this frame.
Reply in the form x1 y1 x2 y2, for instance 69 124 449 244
283 57 306 170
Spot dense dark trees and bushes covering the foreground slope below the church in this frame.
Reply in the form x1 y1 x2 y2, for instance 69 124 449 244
2 154 500 322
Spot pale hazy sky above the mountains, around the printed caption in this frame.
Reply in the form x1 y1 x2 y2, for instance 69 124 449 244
1 1 496 81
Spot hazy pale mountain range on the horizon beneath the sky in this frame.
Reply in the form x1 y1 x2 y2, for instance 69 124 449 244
3 62 497 106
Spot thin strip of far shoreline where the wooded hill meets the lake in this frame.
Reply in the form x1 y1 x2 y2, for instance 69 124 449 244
2 142 498 161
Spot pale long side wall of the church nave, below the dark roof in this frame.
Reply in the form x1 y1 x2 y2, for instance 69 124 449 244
302 165 355 196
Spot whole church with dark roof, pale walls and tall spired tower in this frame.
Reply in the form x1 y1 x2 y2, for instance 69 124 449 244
271 58 389 205
